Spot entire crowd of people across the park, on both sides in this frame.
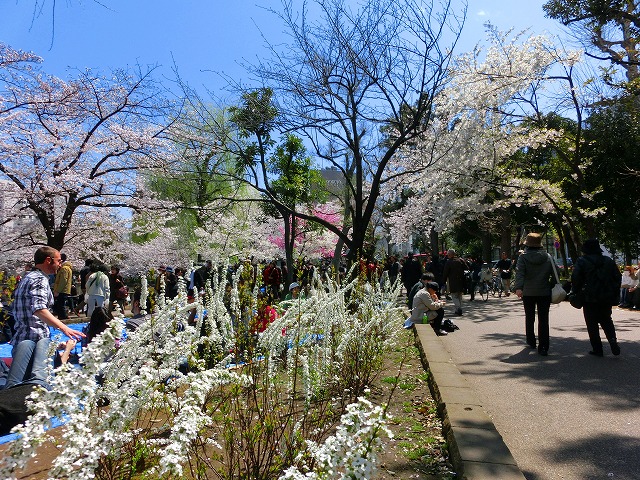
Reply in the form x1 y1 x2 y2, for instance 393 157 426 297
0 240 640 402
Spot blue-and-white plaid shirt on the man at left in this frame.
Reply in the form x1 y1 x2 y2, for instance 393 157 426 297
11 270 53 345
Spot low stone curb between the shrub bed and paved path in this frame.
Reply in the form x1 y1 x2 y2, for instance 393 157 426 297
414 324 525 480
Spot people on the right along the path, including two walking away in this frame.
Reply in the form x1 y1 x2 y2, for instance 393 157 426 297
400 233 640 357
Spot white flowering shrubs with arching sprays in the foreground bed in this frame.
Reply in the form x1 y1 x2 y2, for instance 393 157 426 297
0 262 402 479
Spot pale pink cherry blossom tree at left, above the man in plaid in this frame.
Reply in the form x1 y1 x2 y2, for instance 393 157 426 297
0 45 174 249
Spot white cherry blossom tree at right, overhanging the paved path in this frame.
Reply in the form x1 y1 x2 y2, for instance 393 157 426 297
382 30 588 255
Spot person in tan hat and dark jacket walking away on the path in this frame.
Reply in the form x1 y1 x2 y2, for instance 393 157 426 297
515 233 553 356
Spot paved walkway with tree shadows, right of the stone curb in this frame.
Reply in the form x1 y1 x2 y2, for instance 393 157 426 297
440 295 640 480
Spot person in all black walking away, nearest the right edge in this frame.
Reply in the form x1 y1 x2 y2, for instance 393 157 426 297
571 238 622 357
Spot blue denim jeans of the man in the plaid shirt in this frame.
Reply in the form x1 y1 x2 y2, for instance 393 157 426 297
5 337 51 388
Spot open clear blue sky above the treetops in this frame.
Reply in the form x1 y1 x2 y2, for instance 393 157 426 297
0 0 562 95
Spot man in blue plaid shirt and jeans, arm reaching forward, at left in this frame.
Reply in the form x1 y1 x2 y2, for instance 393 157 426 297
5 247 84 388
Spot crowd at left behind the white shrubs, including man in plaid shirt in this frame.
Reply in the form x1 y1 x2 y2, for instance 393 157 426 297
0 251 342 434
